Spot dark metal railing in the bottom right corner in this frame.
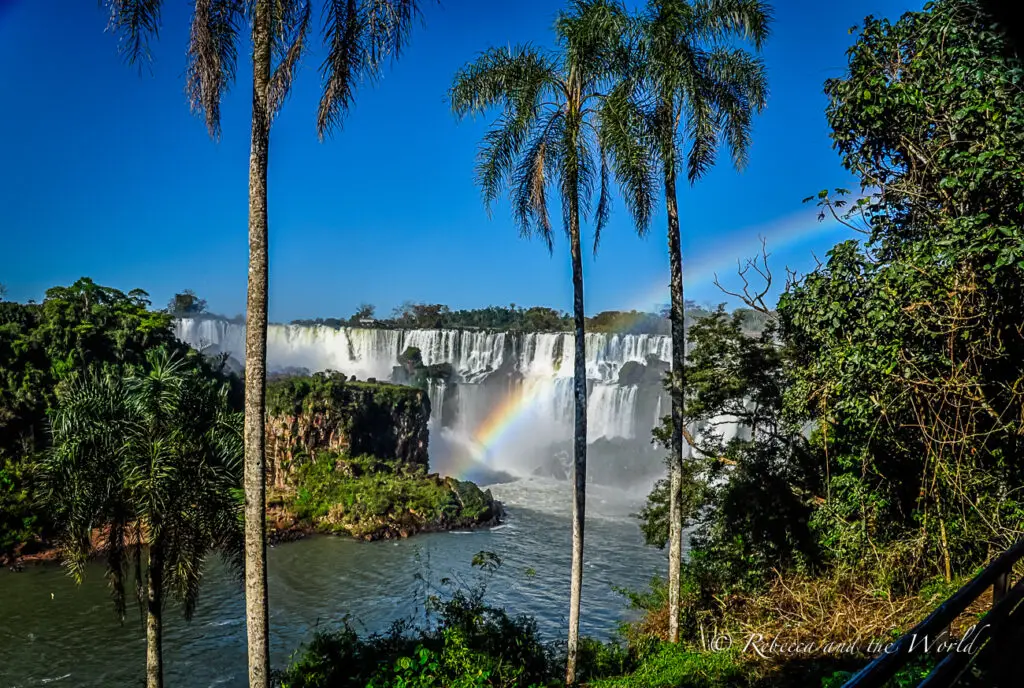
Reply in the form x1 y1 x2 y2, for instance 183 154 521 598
843 540 1024 688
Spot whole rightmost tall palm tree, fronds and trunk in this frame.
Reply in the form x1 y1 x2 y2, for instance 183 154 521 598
640 0 771 642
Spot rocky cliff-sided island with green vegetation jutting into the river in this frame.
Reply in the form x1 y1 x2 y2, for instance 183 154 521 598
266 372 501 540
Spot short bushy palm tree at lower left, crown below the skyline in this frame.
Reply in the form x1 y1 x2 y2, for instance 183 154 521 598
42 351 243 688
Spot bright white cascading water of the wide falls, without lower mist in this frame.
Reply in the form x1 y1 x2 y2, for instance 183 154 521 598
175 318 672 479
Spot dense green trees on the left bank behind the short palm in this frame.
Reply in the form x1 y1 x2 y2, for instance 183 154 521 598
0 277 241 557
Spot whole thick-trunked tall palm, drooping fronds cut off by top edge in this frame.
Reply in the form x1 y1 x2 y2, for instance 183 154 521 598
98 0 420 688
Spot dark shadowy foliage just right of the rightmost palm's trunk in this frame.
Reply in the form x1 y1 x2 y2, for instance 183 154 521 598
639 307 820 590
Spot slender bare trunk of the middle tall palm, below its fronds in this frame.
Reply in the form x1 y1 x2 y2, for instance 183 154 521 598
565 189 587 685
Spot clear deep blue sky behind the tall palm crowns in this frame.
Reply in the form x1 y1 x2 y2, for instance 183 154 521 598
0 0 921 320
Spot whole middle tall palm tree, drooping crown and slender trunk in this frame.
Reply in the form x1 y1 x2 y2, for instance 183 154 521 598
449 0 650 684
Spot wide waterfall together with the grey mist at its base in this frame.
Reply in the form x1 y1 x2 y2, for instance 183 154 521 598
175 318 672 487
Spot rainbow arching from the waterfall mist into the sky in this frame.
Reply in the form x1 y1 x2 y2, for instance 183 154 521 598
449 209 856 478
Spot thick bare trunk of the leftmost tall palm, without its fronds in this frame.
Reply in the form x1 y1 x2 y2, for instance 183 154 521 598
244 0 271 688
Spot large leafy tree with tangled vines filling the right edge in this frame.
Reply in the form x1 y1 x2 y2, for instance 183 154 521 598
779 0 1024 588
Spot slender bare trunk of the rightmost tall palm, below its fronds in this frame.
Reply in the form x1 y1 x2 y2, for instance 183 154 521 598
665 158 686 643
